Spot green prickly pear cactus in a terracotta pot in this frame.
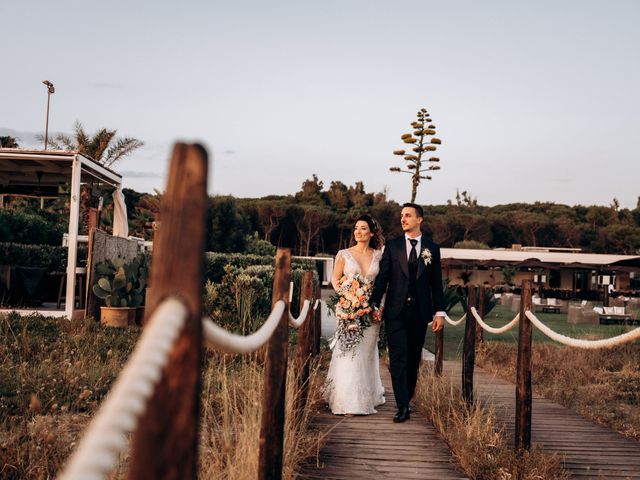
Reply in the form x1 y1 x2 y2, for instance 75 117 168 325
92 257 146 327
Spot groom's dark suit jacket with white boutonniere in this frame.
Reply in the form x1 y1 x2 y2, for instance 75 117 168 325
370 235 444 322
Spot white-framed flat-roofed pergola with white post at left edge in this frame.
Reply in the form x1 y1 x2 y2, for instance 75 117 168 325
0 148 122 319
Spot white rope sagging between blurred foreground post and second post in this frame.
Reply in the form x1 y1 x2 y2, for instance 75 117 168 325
202 300 286 353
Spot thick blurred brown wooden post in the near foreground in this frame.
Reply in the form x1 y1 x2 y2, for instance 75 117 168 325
129 143 207 480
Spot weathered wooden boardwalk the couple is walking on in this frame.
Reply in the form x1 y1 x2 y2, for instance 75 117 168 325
299 364 467 480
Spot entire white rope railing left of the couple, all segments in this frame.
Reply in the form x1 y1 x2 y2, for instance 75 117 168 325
58 290 317 480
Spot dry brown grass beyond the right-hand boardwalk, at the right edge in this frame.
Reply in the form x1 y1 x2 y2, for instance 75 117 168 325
476 342 640 440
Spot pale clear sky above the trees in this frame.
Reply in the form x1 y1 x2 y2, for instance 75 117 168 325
0 0 640 208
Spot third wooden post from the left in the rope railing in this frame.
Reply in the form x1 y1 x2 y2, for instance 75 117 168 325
295 272 315 411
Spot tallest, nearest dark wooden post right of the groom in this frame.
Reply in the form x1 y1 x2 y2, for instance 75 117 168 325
515 280 533 450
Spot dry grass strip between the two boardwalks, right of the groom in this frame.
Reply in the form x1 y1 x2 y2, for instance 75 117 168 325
415 367 569 480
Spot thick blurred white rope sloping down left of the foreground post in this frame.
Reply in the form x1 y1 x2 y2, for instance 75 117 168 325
58 298 188 480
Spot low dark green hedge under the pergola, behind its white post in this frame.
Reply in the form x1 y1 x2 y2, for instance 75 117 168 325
0 243 87 272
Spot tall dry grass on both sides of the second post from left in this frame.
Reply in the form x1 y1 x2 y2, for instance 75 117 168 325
200 350 321 480
